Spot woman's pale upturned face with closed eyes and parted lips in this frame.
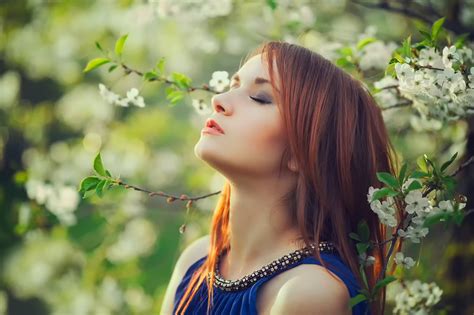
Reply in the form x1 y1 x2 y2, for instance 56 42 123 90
194 54 286 179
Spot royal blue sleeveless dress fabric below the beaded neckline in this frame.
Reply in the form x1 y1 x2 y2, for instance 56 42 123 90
173 253 370 315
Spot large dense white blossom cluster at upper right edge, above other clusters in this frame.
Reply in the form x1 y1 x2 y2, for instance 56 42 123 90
374 46 474 124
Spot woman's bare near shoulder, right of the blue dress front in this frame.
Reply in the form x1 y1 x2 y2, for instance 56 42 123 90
270 265 352 315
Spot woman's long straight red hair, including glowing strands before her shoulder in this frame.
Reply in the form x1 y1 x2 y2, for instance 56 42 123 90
176 41 401 314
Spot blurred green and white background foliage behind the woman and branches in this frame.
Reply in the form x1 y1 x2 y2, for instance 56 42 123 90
0 0 474 314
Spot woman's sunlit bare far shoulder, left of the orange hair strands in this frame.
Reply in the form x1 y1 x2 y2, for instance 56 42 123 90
160 234 210 315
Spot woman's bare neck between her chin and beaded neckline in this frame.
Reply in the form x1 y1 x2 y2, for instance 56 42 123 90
221 179 304 279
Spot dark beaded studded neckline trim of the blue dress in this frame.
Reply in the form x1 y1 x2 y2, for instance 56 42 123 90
207 241 336 292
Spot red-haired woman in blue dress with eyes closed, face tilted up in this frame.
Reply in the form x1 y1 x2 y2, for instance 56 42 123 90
162 41 394 315
